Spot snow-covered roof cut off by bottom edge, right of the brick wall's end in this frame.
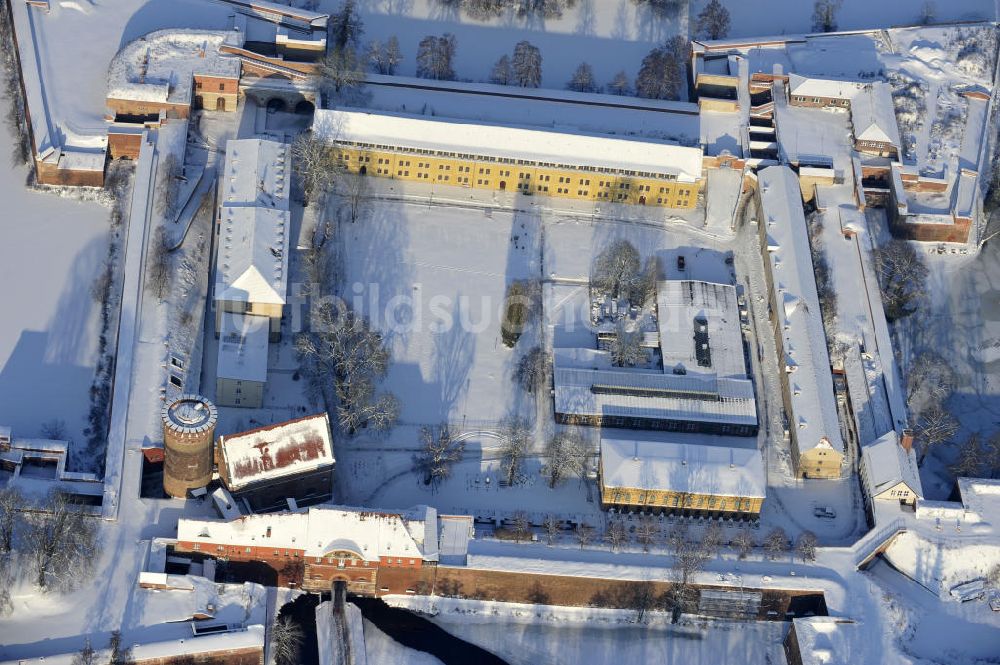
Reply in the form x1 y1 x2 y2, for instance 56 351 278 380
793 617 883 665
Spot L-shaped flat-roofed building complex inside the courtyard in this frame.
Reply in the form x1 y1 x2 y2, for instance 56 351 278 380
553 280 758 436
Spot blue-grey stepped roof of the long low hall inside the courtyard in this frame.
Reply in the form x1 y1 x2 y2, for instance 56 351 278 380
555 364 757 426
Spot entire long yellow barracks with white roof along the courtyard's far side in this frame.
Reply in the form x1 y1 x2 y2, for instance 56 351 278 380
313 109 704 208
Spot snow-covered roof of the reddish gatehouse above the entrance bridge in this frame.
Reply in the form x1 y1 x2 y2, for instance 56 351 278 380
177 506 437 561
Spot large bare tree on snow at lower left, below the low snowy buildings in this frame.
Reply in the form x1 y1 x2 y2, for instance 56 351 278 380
24 491 98 590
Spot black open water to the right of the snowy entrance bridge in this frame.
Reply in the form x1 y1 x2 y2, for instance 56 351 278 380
350 597 508 665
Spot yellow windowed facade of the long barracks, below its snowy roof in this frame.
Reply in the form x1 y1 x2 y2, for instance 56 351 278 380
333 142 701 209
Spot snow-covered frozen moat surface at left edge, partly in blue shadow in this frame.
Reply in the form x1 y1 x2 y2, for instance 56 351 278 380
0 115 110 444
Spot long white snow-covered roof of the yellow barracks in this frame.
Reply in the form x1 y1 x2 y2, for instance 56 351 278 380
313 109 702 182
